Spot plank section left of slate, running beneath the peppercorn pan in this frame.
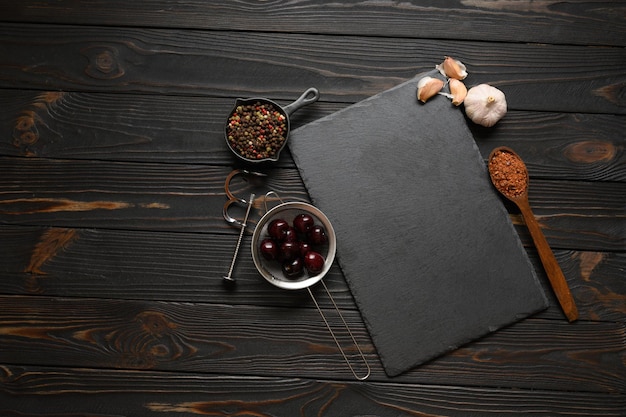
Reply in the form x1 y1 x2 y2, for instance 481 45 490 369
0 90 322 167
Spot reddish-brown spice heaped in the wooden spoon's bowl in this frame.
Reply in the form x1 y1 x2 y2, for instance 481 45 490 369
489 150 528 198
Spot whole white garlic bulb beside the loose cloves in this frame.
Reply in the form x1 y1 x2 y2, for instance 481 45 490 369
464 84 507 127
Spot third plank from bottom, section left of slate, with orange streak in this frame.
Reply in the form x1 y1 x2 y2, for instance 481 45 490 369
0 226 356 310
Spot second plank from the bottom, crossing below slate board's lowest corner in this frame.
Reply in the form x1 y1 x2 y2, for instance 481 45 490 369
0 296 626 393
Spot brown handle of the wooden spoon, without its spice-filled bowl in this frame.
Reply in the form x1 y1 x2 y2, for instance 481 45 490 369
518 199 578 322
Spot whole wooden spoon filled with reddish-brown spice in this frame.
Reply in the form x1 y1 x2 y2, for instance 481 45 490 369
489 146 578 322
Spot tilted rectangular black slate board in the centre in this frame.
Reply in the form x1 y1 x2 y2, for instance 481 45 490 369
289 73 547 376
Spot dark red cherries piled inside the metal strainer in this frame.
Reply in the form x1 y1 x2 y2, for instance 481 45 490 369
259 213 328 279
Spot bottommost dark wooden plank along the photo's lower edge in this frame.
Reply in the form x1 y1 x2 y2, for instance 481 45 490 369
0 365 625 417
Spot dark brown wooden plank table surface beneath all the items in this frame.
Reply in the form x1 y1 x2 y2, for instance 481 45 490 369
0 0 626 417
